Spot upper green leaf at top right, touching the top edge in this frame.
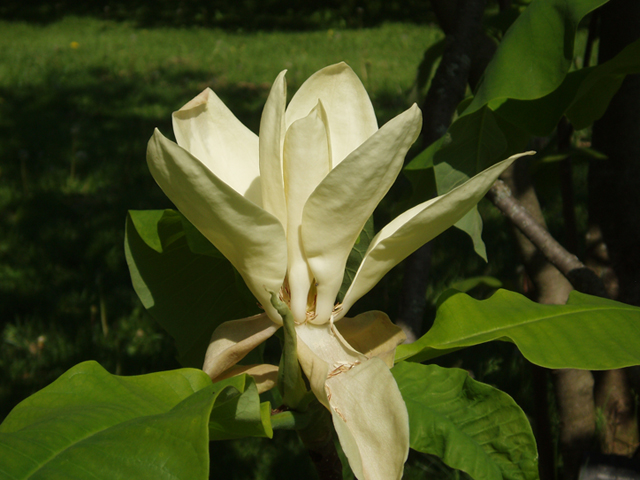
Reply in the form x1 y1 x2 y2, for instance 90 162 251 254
467 0 607 113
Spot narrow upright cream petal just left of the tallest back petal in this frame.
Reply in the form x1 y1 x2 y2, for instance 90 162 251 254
259 70 287 231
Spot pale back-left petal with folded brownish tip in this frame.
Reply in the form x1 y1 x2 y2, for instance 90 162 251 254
172 88 262 205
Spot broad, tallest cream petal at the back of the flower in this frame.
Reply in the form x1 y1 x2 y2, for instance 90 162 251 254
286 63 378 167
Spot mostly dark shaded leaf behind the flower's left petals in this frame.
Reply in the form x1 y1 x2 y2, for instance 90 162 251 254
125 210 259 367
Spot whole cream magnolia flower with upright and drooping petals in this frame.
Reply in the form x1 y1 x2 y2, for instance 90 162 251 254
147 63 532 480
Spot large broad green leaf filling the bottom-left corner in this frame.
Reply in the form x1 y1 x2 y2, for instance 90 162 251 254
0 362 270 480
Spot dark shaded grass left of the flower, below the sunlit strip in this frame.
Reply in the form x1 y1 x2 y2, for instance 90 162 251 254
0 64 268 418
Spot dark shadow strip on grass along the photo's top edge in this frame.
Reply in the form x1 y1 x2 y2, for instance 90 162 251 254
0 0 435 31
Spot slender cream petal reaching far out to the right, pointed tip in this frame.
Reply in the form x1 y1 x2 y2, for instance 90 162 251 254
338 152 534 317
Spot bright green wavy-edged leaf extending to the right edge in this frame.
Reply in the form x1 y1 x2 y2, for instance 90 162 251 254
396 290 640 370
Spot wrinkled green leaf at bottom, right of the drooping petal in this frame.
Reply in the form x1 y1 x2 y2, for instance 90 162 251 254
391 362 538 480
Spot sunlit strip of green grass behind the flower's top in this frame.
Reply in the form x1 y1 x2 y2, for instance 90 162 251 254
0 17 441 117
